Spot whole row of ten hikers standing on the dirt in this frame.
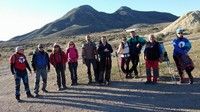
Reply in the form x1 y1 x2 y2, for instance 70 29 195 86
10 29 194 101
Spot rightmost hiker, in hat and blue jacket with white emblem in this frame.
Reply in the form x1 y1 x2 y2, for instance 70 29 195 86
173 28 194 84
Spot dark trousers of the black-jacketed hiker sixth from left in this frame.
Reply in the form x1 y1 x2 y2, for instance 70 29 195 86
99 57 112 83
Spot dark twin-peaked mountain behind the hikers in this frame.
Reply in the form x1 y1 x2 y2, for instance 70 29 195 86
11 5 177 41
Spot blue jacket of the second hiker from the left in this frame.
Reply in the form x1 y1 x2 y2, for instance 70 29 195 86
32 51 50 70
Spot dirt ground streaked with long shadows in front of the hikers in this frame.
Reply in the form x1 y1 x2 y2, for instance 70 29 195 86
0 75 200 112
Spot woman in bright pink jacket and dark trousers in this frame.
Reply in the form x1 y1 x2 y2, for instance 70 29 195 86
66 41 79 86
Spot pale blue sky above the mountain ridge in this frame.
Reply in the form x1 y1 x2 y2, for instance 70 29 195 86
0 0 200 40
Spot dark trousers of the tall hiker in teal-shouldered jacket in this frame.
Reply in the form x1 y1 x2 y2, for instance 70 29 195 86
129 55 139 76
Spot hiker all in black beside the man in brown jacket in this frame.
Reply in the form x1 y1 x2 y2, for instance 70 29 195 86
97 36 113 85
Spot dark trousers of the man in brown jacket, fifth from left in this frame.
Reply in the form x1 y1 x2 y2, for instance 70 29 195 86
85 59 98 82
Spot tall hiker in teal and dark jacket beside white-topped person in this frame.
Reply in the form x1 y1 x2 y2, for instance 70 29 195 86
128 30 146 78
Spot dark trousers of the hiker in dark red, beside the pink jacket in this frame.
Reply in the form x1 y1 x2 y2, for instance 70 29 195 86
55 64 66 88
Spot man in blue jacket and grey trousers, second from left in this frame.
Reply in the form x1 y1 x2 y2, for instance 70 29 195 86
32 44 50 97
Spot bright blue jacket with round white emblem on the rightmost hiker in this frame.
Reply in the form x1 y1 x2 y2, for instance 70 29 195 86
173 37 192 56
